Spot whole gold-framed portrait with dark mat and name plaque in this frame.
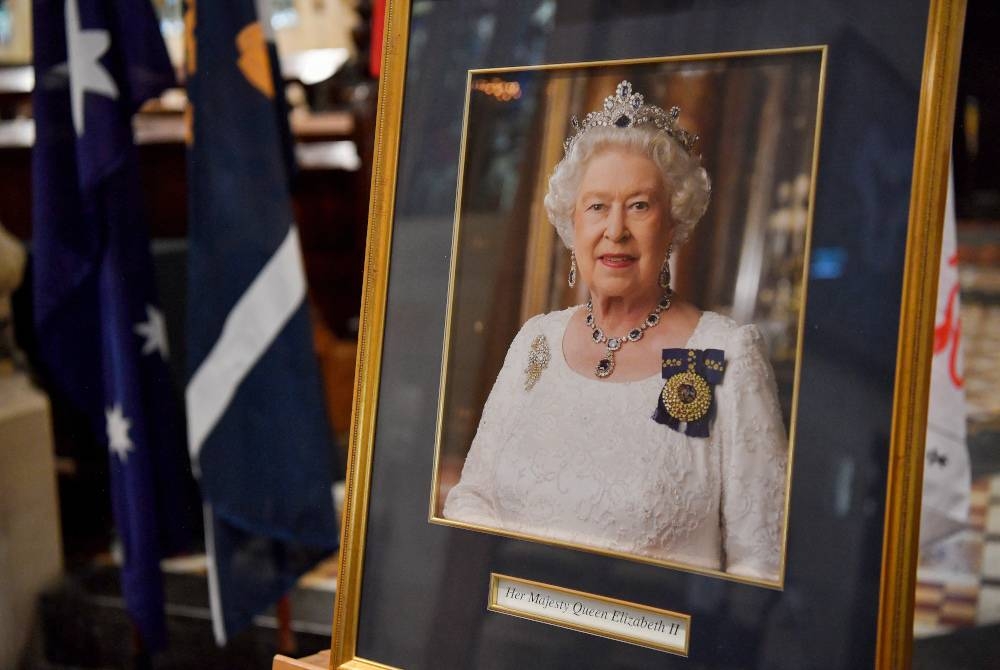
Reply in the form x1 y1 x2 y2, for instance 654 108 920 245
331 0 964 668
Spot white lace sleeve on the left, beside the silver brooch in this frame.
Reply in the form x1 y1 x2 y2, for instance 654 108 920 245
443 317 539 527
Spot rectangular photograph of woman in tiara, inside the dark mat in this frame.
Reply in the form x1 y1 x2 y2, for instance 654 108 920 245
431 51 823 585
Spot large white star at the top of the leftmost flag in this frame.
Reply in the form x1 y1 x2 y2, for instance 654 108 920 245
66 0 118 137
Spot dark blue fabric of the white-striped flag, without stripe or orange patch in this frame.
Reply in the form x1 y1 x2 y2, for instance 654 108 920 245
188 0 338 637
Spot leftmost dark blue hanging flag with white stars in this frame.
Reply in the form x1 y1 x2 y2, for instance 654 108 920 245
32 0 190 650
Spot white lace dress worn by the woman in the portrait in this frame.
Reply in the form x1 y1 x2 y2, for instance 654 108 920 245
444 308 788 581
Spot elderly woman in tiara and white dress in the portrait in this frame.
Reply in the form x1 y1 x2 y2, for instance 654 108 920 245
444 82 788 582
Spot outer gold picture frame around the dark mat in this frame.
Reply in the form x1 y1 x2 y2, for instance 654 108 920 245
330 0 965 670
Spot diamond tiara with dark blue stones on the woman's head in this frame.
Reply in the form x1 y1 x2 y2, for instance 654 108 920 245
563 81 698 154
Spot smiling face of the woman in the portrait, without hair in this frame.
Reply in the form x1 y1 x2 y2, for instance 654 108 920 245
573 148 673 301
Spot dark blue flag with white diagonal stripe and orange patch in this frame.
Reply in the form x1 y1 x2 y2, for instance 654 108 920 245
186 0 338 644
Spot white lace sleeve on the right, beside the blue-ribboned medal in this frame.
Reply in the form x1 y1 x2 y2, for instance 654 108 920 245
719 325 788 580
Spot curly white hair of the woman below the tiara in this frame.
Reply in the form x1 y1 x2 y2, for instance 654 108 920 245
545 126 712 249
